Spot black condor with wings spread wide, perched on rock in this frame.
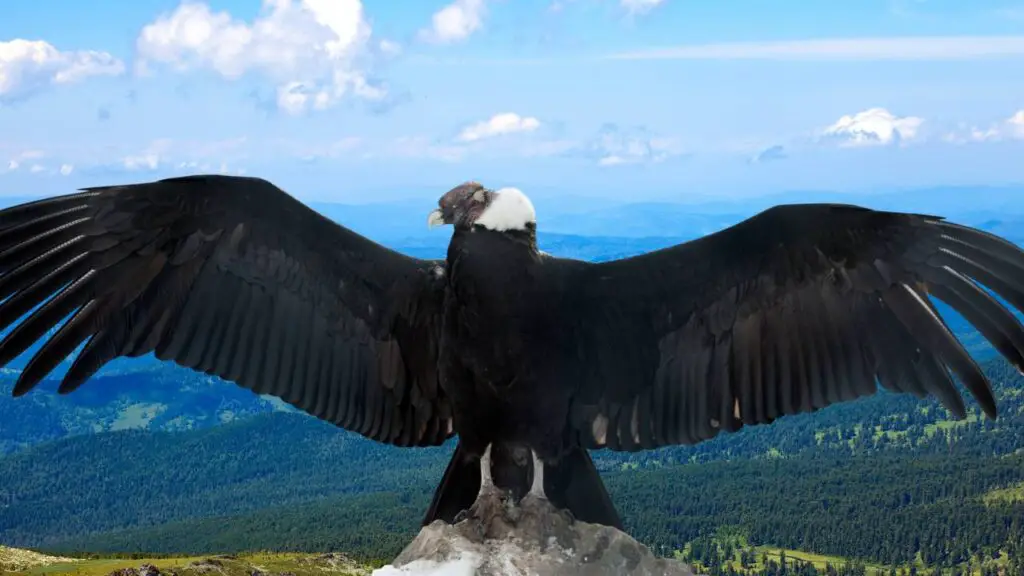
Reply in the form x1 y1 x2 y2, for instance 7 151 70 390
0 175 1024 526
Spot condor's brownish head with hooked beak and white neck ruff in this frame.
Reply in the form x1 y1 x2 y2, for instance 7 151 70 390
427 182 537 232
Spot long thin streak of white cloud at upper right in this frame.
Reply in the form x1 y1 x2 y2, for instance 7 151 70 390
609 36 1024 60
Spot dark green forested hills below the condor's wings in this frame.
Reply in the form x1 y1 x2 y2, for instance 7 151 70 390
0 360 1024 574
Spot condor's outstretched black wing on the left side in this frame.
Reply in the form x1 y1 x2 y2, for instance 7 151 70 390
0 175 452 446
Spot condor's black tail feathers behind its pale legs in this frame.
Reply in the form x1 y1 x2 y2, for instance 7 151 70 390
423 443 623 530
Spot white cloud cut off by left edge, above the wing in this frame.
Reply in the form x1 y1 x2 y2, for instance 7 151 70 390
0 39 125 101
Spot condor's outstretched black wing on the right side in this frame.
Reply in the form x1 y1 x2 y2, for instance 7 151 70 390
572 204 1024 450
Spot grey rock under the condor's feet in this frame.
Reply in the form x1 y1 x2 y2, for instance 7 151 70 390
373 491 694 576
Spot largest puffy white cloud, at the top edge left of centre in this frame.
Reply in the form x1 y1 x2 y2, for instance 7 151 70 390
136 0 386 114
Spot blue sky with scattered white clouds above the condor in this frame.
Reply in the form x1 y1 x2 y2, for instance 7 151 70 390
0 0 1024 203
